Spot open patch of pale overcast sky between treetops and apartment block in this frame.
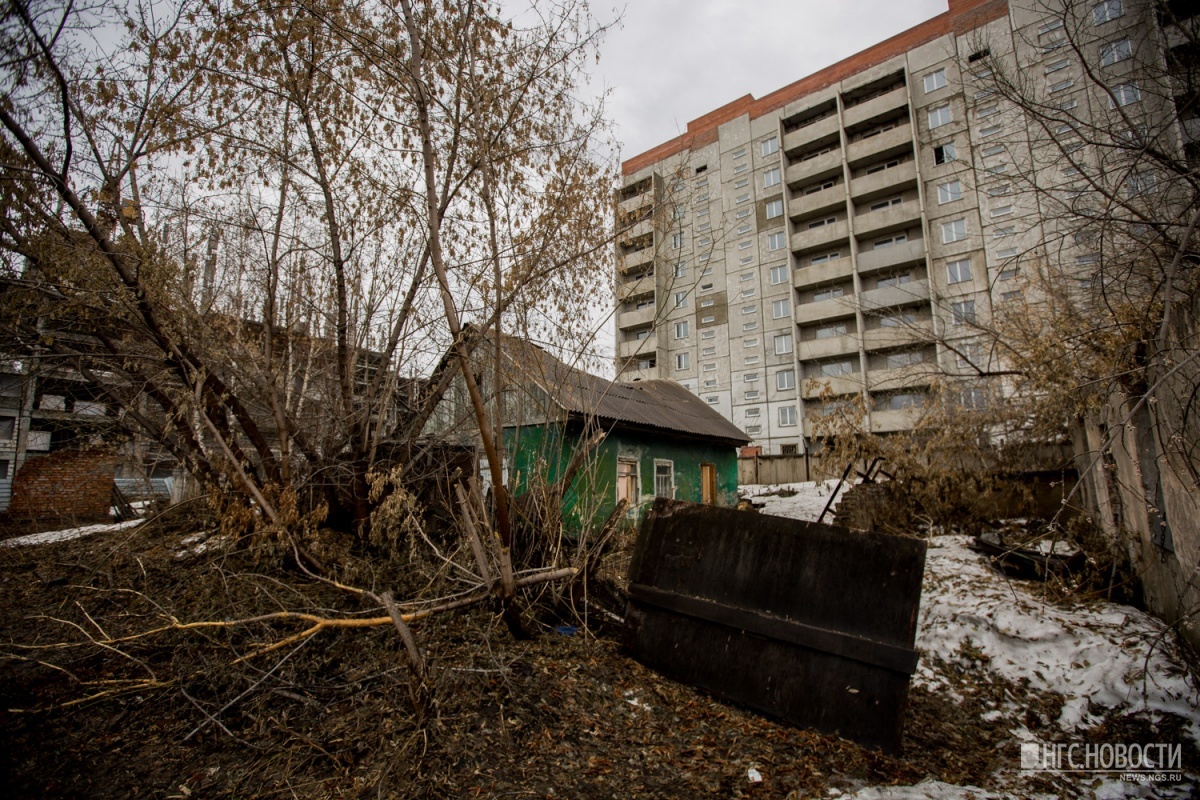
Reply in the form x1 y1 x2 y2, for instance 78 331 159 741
593 0 947 158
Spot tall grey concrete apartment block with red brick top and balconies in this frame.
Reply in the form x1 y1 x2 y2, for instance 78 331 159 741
616 0 1176 455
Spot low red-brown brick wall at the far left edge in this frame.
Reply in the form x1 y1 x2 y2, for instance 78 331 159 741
8 450 118 522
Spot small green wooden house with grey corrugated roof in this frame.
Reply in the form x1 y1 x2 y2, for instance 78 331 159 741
422 337 750 533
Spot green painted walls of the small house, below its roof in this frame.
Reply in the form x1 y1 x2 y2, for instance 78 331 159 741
504 423 738 533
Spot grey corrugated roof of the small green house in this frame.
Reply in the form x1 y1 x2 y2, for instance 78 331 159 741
492 336 750 444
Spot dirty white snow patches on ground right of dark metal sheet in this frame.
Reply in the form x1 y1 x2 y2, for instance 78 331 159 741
742 481 1200 800
